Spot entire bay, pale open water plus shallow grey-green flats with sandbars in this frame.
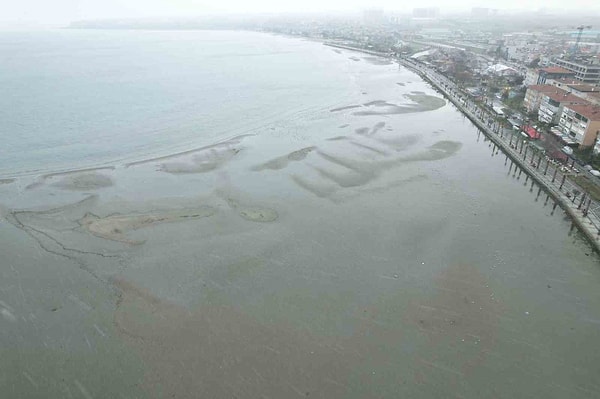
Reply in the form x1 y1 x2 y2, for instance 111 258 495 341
0 31 600 398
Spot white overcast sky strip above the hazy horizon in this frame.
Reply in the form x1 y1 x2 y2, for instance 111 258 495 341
0 0 600 25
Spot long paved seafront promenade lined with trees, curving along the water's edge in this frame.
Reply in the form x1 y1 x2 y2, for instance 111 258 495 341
398 58 600 252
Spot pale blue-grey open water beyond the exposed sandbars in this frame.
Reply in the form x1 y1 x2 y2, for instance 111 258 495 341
0 30 349 176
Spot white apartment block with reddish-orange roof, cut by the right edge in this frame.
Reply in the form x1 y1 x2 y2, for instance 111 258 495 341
558 104 600 153
